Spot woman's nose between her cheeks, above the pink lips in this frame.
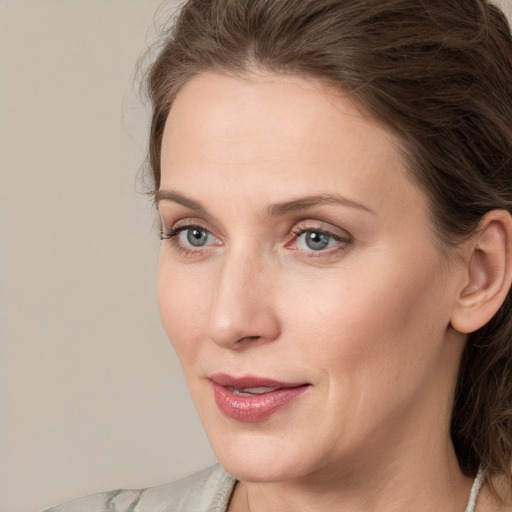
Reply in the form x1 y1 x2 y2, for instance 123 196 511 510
208 249 280 350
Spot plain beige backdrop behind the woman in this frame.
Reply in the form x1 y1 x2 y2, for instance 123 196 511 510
0 0 512 512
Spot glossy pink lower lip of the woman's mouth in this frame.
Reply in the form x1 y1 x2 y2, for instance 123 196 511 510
212 382 310 423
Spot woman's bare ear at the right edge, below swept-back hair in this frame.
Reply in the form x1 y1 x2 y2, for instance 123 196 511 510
450 210 512 333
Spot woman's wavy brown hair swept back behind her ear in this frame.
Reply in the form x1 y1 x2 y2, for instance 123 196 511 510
143 0 512 494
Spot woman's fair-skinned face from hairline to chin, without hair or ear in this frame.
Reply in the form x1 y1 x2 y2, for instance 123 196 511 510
157 73 463 481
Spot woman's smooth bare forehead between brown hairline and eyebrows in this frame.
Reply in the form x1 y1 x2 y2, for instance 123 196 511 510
161 73 423 225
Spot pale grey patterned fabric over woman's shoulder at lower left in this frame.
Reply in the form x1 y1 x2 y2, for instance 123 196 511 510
45 464 236 512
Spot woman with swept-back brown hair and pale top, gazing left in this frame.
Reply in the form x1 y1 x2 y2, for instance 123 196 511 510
45 0 512 512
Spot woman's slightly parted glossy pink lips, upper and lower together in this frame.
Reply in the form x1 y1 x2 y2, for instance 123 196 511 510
210 373 310 422
